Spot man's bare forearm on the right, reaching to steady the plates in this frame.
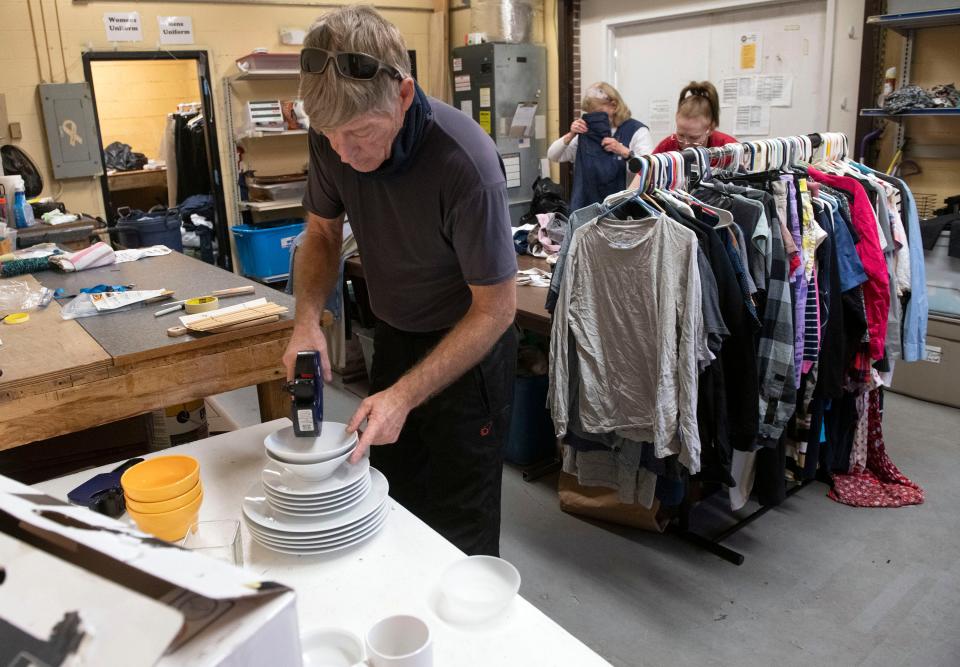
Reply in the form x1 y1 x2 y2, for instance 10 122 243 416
393 282 516 407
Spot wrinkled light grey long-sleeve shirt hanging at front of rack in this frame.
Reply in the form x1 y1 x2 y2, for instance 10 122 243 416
548 216 704 474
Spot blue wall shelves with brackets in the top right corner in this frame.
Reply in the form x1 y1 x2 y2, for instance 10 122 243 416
860 9 960 157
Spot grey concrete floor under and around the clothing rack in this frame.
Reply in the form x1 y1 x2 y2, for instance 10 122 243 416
218 389 960 667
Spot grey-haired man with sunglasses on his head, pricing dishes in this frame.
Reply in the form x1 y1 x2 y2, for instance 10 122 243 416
283 6 517 555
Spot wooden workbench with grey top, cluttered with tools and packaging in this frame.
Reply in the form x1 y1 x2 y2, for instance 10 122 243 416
0 252 294 450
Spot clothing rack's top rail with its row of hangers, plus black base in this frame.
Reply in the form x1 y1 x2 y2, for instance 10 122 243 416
523 132 849 565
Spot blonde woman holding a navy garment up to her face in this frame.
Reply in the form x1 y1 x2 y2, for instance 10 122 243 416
547 81 653 211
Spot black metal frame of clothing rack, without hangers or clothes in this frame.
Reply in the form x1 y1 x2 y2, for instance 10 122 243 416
523 133 847 565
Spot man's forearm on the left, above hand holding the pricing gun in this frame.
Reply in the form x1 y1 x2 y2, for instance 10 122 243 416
293 214 343 325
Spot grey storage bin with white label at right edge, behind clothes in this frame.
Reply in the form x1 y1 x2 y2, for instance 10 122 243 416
890 316 960 408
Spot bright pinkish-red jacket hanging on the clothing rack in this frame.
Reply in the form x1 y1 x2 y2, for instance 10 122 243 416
807 168 890 360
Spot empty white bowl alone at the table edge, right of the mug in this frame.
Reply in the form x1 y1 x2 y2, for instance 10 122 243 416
440 556 520 623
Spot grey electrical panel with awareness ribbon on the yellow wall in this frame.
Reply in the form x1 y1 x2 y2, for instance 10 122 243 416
39 83 103 178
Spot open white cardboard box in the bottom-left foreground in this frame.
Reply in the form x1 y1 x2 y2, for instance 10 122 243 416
0 477 301 667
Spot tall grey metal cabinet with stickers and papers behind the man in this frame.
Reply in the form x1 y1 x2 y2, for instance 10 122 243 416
451 44 547 225
